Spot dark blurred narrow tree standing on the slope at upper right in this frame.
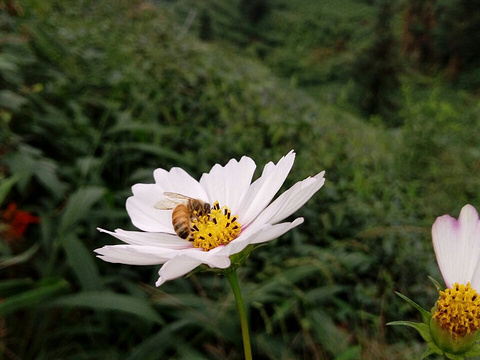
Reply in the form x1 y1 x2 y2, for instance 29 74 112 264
352 0 400 126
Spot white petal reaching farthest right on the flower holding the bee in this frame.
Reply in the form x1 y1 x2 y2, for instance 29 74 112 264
252 171 325 225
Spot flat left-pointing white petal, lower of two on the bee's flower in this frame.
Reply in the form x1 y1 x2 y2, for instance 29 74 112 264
95 245 178 265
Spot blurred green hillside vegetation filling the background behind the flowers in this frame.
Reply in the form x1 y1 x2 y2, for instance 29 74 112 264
0 0 480 360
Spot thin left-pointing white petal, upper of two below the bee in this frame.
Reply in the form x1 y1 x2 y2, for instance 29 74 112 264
97 228 193 250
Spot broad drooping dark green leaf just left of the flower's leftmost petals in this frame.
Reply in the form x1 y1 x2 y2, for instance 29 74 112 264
63 235 103 290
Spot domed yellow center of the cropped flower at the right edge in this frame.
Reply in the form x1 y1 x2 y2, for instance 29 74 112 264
433 283 480 337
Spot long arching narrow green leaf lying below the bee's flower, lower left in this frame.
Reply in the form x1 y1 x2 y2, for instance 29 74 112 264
50 291 164 324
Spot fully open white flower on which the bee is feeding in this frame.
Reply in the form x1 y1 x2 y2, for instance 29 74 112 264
95 151 325 286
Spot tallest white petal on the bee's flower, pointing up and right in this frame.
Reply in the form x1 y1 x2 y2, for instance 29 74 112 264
236 150 295 225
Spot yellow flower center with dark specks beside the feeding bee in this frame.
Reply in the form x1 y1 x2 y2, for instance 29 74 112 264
187 201 242 251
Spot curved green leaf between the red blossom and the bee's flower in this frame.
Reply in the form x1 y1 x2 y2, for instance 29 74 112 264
58 186 105 234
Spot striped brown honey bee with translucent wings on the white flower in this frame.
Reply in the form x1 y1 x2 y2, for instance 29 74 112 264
155 192 210 239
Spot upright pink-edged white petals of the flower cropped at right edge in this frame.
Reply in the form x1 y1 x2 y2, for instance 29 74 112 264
432 205 480 291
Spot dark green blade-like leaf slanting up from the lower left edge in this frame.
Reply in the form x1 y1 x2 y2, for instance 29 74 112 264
0 279 69 317
